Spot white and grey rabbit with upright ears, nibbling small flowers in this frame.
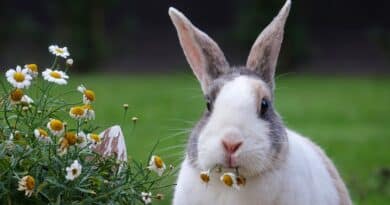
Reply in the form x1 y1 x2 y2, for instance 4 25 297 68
168 0 352 205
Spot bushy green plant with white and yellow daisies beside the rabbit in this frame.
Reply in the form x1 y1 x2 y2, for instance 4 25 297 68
0 45 172 204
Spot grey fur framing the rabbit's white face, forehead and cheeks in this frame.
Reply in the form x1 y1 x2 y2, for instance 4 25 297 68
187 67 287 167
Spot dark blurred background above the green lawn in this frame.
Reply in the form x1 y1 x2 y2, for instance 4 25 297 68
0 0 390 75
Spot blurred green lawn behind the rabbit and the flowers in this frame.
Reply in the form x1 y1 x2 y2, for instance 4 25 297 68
71 74 390 205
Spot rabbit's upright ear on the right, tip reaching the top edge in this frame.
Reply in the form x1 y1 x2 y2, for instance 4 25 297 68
246 0 291 89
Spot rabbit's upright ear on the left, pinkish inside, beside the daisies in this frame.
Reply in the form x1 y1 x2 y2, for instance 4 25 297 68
169 7 229 92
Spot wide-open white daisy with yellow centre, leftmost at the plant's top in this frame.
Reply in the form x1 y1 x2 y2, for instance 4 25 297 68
5 66 32 88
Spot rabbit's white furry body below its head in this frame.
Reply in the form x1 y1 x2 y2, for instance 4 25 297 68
173 131 340 205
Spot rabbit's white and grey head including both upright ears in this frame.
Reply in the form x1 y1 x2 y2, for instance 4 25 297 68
169 0 291 176
